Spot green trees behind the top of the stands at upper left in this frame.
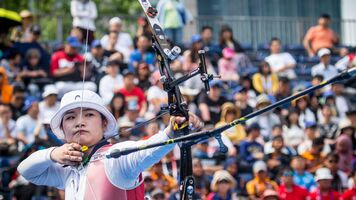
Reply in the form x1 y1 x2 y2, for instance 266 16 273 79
0 0 142 41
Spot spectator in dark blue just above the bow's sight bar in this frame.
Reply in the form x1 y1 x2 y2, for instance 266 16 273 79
200 26 221 67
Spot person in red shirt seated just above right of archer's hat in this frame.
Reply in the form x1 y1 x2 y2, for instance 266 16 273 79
118 70 147 117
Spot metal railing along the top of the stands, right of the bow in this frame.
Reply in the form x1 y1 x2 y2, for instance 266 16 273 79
197 16 356 48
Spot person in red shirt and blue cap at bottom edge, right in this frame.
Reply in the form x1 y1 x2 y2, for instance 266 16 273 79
278 168 309 200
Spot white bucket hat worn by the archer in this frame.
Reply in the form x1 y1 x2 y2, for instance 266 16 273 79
51 90 118 139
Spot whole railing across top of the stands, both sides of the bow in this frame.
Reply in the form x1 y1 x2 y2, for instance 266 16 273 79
37 14 356 49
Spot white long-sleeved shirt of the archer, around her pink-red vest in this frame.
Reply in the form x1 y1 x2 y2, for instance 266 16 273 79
18 131 174 199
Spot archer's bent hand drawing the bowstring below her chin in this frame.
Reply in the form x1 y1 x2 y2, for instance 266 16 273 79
51 143 83 166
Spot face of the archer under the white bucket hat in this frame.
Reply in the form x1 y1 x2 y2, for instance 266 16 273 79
62 108 106 146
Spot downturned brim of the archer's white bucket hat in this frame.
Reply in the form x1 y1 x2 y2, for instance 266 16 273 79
50 101 118 139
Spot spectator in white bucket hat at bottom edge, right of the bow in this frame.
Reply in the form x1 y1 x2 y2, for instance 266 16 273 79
207 170 236 200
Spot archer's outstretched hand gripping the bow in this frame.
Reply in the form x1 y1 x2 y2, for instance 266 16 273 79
166 112 204 138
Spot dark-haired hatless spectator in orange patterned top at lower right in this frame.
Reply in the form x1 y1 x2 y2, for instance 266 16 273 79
301 138 325 173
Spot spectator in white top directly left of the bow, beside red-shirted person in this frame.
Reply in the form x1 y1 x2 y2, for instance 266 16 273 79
147 70 168 116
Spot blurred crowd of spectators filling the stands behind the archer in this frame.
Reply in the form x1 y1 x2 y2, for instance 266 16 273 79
0 0 356 200
